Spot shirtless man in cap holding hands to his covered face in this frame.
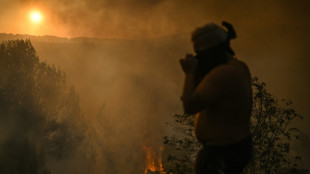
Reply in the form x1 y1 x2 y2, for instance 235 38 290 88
180 22 252 174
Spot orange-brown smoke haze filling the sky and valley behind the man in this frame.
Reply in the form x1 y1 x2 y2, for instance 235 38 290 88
0 0 310 173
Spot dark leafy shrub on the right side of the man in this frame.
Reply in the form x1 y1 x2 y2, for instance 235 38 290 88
245 78 305 174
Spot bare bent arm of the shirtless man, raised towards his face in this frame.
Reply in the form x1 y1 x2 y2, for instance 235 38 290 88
182 60 237 114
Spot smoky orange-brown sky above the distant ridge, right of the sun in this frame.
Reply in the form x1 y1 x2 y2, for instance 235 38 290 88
10 0 309 38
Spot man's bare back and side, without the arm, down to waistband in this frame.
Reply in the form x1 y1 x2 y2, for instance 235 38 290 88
195 60 252 145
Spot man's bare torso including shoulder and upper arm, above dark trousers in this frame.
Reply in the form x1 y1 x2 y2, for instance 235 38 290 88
195 59 252 145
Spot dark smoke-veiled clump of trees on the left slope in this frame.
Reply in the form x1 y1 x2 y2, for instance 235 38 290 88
0 40 91 174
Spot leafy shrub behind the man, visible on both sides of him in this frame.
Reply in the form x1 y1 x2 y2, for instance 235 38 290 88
163 77 307 174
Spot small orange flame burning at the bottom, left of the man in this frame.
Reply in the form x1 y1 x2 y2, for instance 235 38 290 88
143 146 166 174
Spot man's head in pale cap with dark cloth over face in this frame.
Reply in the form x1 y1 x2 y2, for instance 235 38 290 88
192 22 236 76
